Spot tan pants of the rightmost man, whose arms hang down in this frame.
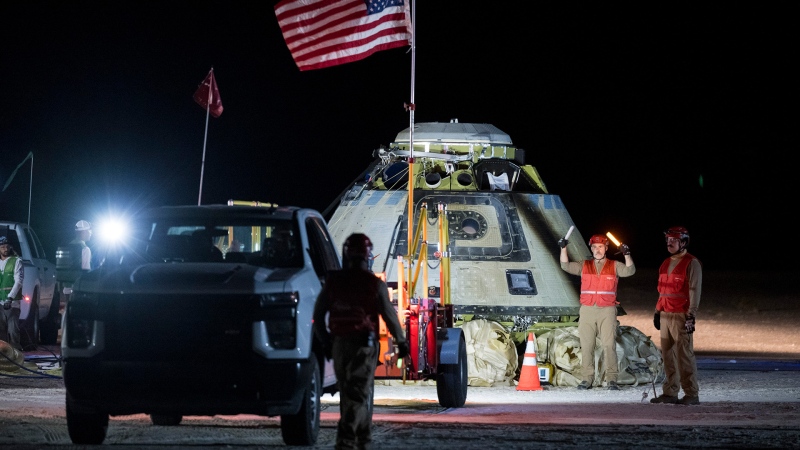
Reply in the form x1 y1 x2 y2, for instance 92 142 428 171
661 311 700 397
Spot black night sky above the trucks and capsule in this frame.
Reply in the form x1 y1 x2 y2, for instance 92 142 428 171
0 0 798 269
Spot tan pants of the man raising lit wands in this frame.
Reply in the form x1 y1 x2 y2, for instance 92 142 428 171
578 305 619 385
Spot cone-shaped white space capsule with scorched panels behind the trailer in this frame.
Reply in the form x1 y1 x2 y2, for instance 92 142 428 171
329 120 590 342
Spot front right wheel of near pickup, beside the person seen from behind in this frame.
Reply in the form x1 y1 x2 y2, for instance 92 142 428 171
281 353 322 445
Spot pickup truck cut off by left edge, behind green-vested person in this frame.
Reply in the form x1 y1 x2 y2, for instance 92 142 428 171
0 220 61 350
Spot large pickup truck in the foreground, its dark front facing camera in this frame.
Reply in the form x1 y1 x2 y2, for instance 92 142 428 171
59 201 341 446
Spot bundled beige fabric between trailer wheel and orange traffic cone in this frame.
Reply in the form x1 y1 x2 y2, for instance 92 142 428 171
461 319 519 387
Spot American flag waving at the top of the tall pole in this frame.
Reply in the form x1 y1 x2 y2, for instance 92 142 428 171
275 0 411 71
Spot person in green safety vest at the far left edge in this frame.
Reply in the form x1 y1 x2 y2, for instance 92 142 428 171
0 236 24 351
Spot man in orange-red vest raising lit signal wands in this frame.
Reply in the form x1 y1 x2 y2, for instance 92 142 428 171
558 234 636 391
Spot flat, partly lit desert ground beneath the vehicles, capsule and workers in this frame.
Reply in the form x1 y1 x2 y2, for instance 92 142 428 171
0 269 800 450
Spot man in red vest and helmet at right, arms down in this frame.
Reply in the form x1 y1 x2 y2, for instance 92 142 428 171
650 227 703 405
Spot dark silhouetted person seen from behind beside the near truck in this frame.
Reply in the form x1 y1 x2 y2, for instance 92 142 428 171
314 233 409 449
